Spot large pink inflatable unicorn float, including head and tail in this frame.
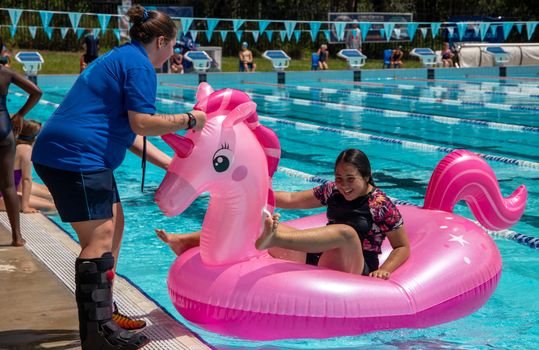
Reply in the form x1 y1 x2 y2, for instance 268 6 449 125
156 83 527 340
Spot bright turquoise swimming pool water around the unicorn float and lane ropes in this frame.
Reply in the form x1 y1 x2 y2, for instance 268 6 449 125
8 68 539 349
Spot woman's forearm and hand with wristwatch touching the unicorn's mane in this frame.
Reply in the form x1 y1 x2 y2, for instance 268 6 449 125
128 110 206 136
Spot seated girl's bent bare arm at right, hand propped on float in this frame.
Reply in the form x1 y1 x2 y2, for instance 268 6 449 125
369 225 410 279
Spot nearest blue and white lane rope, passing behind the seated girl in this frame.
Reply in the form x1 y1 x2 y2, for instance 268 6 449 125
277 166 539 249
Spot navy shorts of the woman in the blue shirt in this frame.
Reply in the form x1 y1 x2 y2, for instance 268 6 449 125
34 163 120 222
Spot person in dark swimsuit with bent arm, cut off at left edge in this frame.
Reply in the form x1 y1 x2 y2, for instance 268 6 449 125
0 61 42 247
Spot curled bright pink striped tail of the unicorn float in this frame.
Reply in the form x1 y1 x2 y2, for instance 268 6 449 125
423 150 528 231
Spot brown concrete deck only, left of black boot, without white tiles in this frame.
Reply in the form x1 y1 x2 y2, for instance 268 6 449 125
0 225 80 350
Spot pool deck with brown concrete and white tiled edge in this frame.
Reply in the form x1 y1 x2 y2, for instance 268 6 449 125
0 212 210 350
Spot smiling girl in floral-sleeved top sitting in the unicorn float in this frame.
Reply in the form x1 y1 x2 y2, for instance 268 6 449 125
155 149 410 279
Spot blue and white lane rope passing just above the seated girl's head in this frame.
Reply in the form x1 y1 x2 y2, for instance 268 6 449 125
153 93 539 169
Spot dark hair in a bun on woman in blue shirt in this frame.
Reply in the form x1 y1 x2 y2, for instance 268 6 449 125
126 5 177 44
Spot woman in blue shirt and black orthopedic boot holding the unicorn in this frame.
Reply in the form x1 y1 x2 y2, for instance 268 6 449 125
33 5 206 350
